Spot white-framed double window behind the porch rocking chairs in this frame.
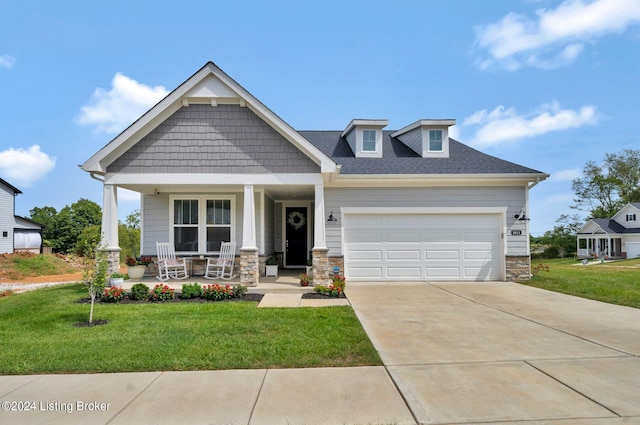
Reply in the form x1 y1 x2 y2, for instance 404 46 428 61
171 196 234 254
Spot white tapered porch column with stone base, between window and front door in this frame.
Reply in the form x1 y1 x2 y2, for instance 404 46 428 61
240 184 260 286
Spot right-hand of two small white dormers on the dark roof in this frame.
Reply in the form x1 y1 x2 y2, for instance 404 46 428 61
391 119 456 158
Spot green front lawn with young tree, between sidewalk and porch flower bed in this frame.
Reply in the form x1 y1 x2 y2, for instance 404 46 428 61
0 284 382 375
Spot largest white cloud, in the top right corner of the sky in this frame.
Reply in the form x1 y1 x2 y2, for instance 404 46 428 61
475 0 640 71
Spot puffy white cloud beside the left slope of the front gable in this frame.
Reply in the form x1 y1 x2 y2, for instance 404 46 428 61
78 73 168 133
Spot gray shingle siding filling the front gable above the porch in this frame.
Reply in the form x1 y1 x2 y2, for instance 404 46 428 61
108 105 320 173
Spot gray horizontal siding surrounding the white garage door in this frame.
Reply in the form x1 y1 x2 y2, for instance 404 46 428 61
325 187 529 255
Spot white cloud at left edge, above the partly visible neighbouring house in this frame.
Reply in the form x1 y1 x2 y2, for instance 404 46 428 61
0 145 56 186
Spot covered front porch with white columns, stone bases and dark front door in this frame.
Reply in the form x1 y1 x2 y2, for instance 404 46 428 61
102 174 335 286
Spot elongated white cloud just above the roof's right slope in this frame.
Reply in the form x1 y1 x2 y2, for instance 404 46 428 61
463 101 598 148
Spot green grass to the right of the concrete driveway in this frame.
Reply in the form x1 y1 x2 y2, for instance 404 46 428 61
520 255 640 308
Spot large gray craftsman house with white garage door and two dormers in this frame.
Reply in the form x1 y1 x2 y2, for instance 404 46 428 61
82 62 548 285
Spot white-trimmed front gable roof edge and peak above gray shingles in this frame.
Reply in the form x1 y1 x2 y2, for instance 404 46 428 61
82 62 336 174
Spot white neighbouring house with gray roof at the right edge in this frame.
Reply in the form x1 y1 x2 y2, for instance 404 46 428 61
577 202 640 258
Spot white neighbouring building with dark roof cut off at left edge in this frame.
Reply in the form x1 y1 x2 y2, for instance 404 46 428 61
0 178 42 254
